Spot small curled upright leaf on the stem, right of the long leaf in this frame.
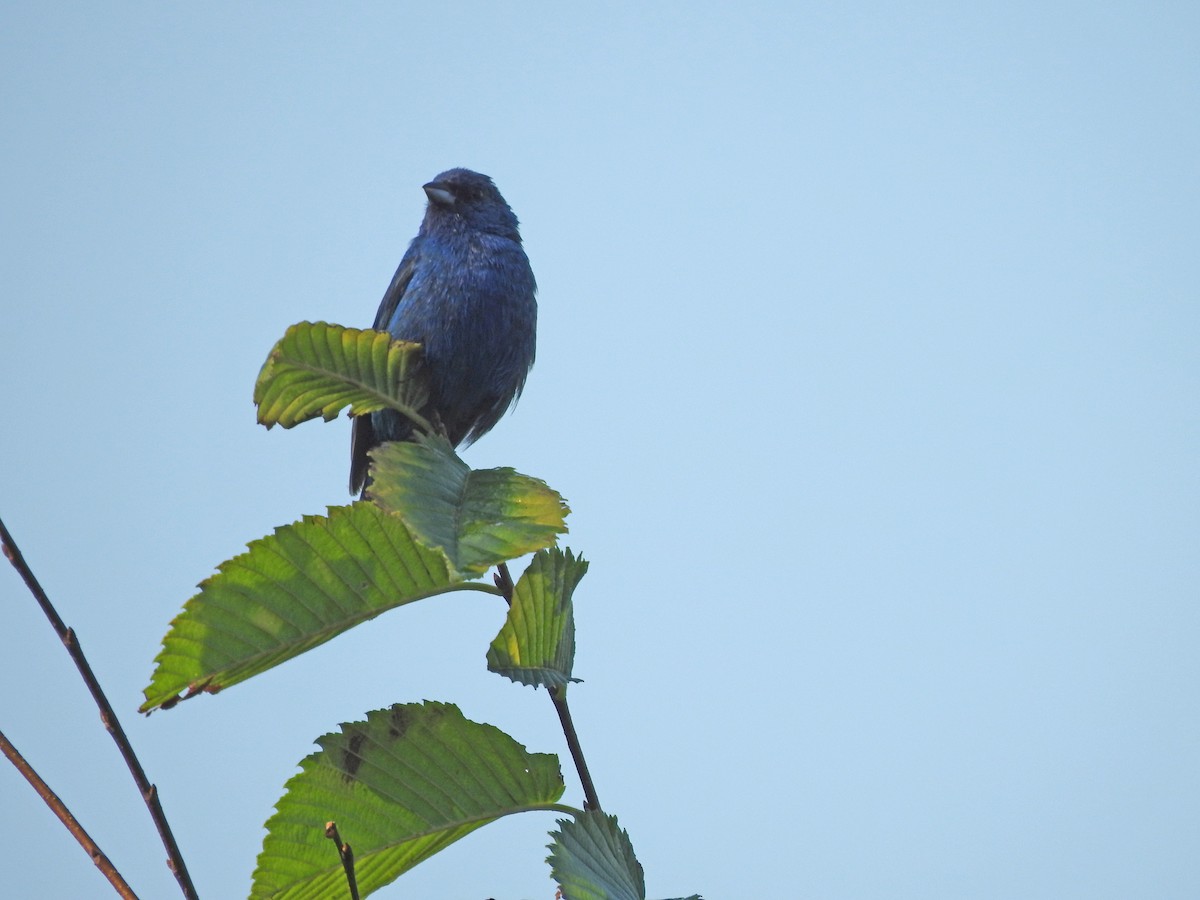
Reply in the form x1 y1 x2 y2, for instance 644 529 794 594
487 547 588 688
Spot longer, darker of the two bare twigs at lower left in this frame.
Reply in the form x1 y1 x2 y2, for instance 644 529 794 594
0 520 199 900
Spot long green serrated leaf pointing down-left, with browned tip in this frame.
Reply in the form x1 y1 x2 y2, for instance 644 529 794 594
142 502 477 712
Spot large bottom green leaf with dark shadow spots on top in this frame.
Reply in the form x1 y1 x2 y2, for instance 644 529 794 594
251 702 564 900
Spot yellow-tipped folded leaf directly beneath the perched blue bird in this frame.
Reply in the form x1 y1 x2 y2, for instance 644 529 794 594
368 437 570 576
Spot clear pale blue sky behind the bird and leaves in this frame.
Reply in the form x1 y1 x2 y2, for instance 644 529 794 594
0 2 1200 900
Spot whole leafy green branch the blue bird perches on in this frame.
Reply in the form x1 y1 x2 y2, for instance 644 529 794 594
142 323 698 900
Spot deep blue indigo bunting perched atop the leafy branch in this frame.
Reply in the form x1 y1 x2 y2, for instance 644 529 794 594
350 169 538 493
